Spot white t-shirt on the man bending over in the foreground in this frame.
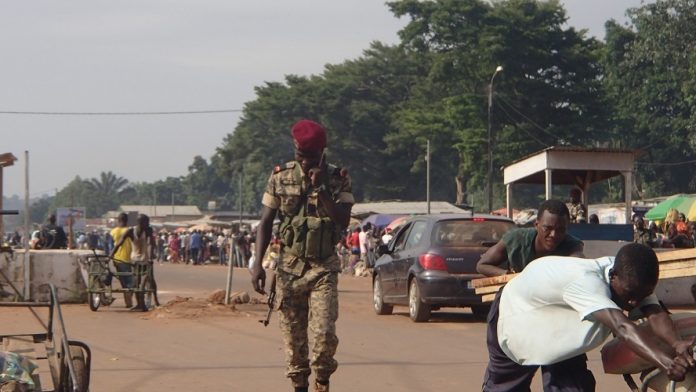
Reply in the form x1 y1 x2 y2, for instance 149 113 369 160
498 256 658 365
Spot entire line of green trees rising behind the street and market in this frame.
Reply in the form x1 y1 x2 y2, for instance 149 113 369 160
24 0 696 220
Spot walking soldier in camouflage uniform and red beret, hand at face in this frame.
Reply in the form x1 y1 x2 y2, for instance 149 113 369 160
252 120 354 392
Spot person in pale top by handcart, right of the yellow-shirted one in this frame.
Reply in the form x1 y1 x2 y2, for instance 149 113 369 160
111 214 155 312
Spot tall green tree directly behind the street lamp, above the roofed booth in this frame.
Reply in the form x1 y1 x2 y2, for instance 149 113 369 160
388 0 605 210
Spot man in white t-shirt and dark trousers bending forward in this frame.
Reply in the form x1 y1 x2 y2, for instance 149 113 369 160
483 243 696 392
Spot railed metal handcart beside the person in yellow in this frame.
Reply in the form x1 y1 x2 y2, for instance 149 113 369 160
87 250 160 312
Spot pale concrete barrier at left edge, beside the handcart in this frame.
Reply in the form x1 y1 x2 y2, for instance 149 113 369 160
0 249 92 303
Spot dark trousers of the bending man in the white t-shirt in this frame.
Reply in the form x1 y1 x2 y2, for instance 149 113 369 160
482 289 595 392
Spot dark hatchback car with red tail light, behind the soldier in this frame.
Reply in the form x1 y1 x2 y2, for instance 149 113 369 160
372 214 515 322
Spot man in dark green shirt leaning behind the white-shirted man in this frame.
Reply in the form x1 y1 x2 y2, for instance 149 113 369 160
476 200 584 276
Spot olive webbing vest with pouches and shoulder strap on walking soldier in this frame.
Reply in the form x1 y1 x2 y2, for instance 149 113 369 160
279 164 339 259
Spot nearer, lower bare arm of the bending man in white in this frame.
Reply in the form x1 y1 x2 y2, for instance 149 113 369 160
592 309 694 381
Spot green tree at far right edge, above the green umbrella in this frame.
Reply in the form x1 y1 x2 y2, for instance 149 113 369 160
603 0 696 197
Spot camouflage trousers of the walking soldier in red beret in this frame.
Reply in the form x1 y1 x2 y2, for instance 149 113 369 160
277 268 338 387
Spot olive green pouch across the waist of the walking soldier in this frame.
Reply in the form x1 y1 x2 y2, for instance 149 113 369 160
280 216 338 259
